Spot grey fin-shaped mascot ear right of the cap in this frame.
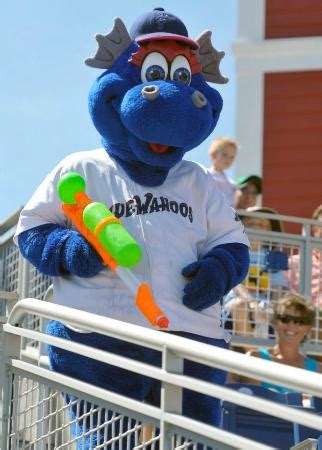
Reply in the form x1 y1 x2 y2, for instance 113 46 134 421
196 31 228 84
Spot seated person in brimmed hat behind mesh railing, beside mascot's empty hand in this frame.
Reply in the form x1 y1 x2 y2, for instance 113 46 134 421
224 207 288 338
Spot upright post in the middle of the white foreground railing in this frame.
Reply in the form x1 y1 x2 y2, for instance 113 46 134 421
160 347 183 450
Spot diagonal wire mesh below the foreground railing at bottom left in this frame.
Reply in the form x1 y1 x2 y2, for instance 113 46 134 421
7 374 211 450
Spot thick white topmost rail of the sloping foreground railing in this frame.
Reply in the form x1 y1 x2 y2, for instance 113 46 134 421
4 298 322 396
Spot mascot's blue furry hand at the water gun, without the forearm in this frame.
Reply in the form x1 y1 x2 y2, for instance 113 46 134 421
63 231 103 277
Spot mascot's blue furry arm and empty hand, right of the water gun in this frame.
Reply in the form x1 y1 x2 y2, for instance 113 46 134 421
181 244 249 311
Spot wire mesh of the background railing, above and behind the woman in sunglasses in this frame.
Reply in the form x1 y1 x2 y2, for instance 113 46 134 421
224 232 322 346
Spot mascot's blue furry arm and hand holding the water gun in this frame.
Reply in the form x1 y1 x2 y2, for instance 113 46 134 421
18 224 103 277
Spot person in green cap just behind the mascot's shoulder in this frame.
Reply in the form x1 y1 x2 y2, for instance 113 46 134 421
234 175 263 209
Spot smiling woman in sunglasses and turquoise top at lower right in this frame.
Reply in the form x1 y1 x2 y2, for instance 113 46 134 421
242 293 322 393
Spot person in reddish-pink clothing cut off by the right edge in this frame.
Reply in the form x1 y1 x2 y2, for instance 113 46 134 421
286 205 322 307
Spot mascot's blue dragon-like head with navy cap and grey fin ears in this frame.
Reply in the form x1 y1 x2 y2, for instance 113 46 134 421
85 8 228 186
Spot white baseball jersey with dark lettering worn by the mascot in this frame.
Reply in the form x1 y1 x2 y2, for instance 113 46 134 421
15 149 249 339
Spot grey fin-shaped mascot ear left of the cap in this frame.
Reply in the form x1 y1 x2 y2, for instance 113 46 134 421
85 17 132 69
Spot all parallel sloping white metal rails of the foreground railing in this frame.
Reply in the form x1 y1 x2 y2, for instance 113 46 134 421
4 298 322 449
